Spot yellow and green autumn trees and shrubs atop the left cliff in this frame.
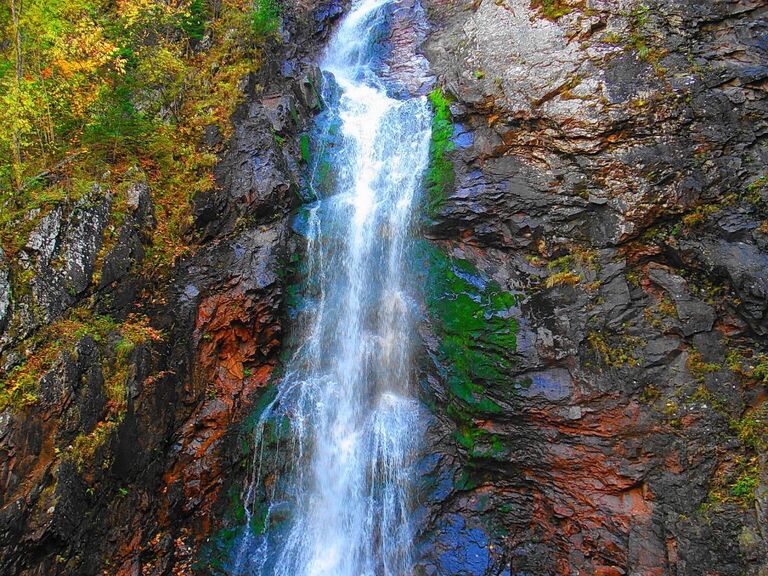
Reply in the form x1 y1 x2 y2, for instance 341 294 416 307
0 0 279 267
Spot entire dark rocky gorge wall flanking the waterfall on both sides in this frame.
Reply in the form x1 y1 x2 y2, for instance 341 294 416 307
0 0 768 576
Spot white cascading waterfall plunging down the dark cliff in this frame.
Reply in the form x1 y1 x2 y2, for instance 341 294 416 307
232 0 431 576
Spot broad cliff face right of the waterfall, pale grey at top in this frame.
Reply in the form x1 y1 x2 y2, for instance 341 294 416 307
414 0 768 575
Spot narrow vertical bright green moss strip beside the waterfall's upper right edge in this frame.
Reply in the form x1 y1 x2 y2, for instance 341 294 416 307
427 88 456 215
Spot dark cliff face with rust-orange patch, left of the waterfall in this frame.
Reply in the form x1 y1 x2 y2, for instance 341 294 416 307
0 3 340 575
